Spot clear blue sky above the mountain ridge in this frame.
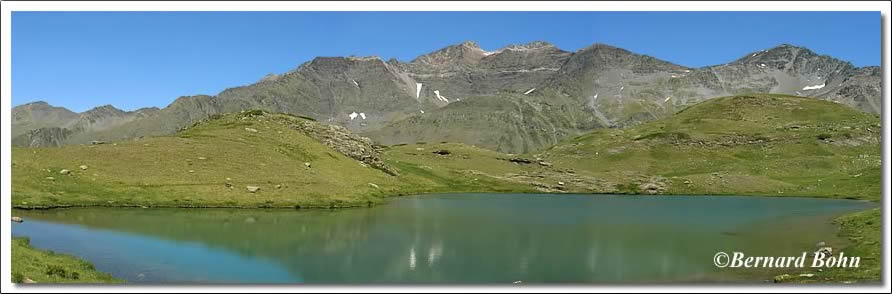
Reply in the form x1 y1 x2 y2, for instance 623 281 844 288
11 11 882 111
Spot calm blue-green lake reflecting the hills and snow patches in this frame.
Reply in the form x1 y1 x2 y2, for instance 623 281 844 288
12 194 874 284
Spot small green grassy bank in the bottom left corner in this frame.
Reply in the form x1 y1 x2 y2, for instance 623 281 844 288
11 238 123 284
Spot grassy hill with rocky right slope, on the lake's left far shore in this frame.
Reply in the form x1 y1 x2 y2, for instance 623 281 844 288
12 111 531 208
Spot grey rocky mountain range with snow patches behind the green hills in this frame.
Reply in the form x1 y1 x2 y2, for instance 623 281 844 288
12 41 882 153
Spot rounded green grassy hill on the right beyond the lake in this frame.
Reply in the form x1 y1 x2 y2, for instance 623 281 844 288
540 95 882 200
